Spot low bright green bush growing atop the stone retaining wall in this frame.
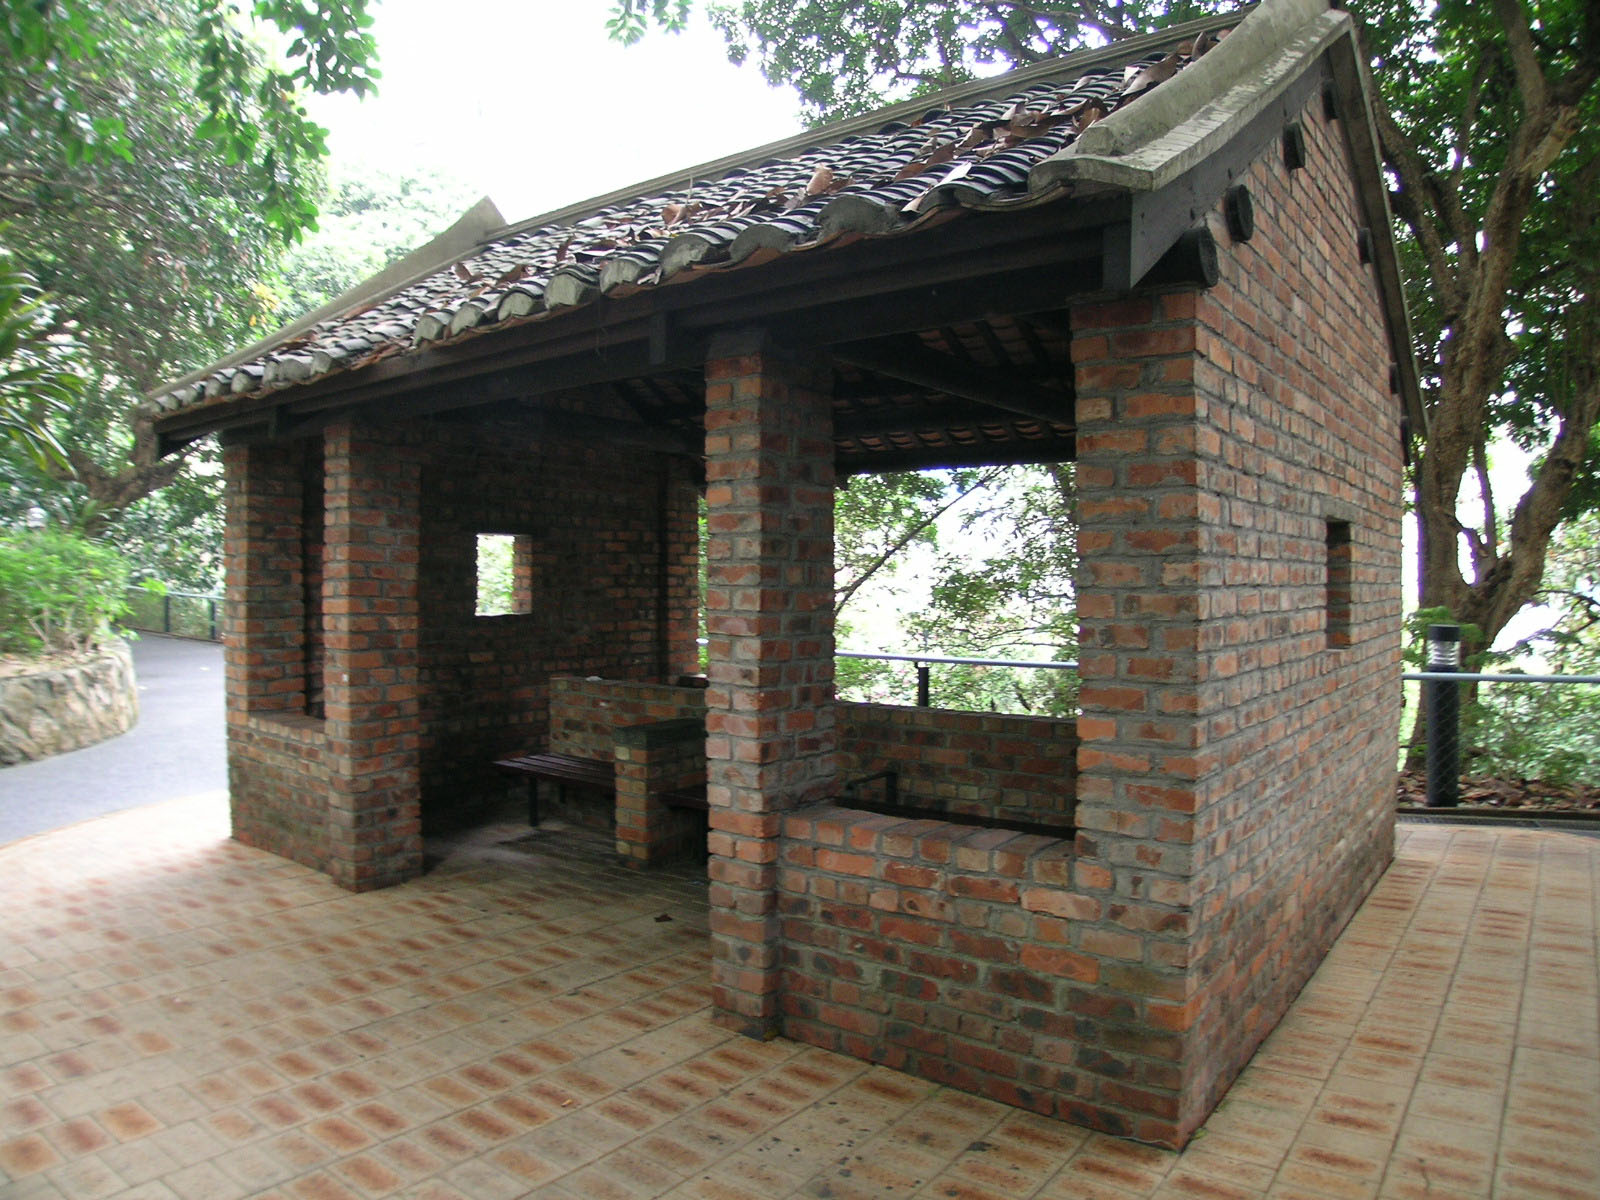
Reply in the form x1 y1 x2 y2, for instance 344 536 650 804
0 530 128 656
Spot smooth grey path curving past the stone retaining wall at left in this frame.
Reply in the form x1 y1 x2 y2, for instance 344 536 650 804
0 634 227 845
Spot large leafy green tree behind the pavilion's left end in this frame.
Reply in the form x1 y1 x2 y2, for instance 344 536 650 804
0 0 390 587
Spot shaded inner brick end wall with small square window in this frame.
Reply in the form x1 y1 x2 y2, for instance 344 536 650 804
421 400 699 829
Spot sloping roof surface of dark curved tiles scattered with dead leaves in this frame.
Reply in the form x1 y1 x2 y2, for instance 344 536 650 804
154 18 1227 414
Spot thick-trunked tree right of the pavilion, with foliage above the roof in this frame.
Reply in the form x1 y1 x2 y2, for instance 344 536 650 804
613 0 1600 668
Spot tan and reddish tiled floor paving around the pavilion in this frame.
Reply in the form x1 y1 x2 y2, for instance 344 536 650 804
0 802 1600 1200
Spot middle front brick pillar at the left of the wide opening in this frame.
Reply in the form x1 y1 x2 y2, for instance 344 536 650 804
706 334 835 1037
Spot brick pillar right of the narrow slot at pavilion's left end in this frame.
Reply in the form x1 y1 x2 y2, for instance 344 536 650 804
323 424 422 891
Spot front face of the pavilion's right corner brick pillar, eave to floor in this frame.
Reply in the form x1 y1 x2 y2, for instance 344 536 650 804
1067 293 1203 1146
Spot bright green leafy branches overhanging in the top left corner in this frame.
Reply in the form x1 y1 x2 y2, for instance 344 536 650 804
0 0 378 240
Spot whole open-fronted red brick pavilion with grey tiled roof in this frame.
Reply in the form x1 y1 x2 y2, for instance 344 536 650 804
150 0 1421 1146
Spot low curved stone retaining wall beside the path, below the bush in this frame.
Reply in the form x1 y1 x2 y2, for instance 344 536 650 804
0 642 139 766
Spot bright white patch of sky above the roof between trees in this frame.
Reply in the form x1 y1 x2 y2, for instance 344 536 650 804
309 0 802 221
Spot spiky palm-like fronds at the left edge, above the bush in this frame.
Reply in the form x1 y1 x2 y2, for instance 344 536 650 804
0 248 74 469
